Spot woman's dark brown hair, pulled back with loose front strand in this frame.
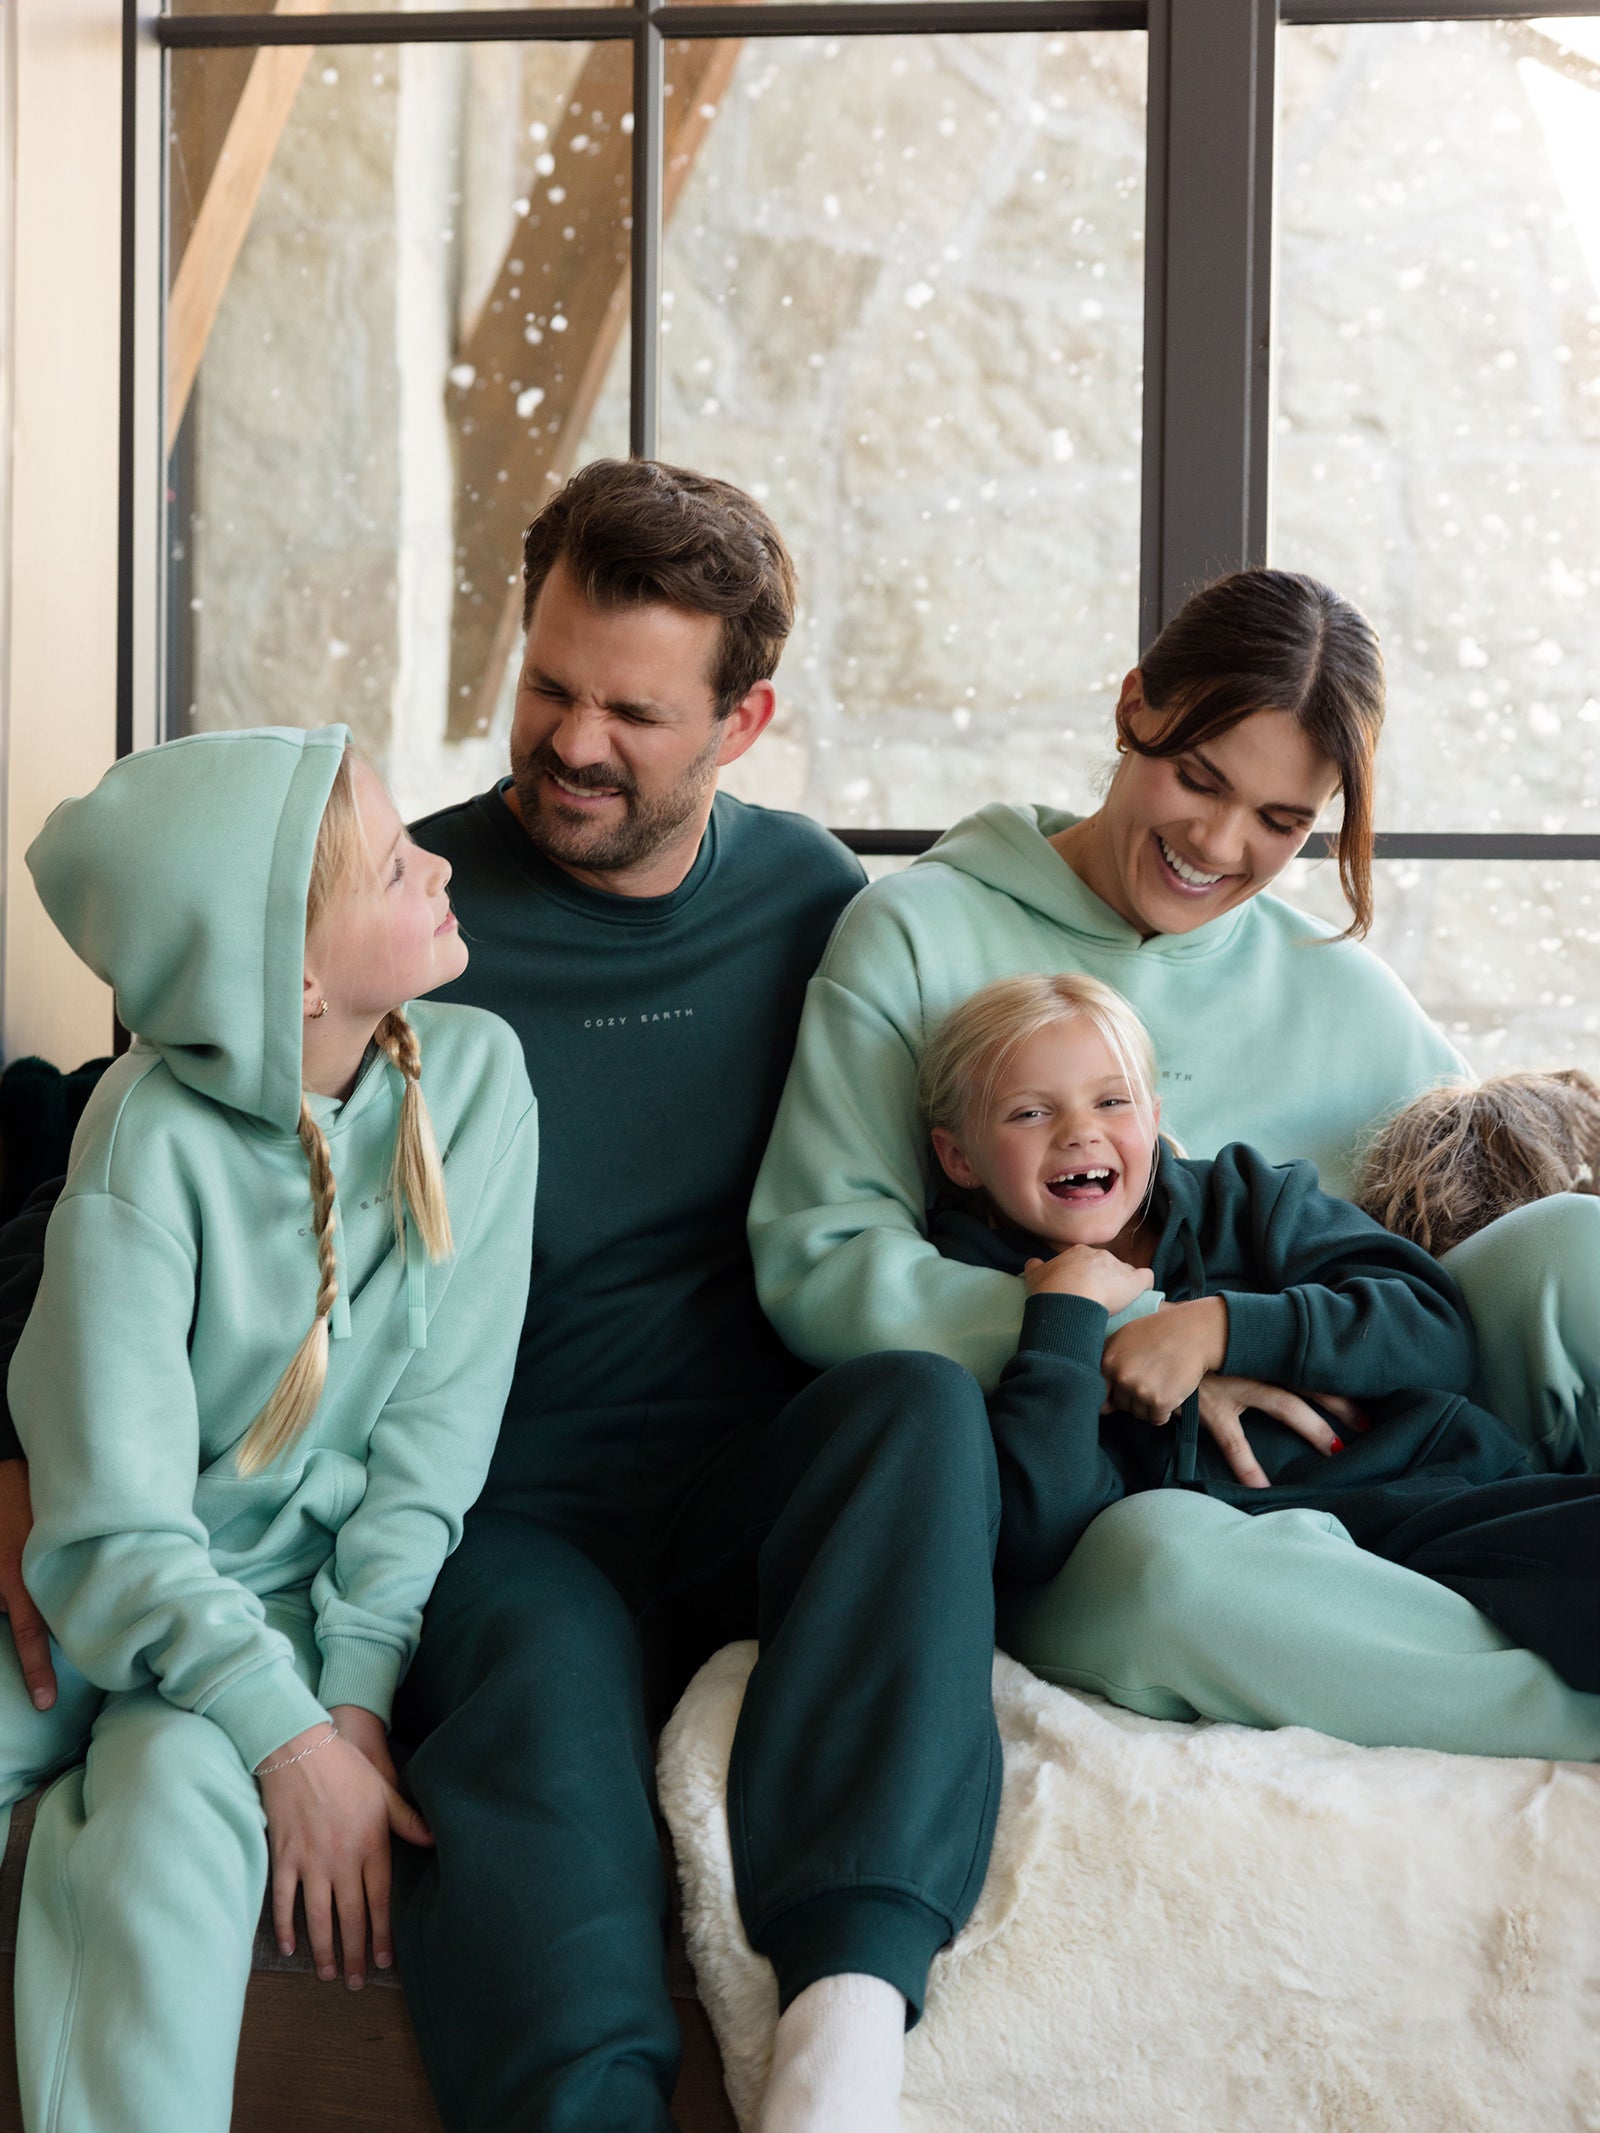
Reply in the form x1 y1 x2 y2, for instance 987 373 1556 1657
1118 570 1385 941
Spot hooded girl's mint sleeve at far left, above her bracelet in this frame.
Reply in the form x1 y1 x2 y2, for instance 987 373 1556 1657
11 1192 326 1768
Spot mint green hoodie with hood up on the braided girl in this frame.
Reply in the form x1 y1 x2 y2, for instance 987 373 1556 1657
9 727 535 1766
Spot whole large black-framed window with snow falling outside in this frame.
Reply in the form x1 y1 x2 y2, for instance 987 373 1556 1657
124 0 1600 1067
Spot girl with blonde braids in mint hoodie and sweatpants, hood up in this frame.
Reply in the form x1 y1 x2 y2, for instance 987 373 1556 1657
0 727 535 2133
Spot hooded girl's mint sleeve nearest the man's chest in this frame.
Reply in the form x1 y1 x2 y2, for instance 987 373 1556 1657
311 1083 538 1723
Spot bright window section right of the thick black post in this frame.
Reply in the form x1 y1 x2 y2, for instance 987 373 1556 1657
1271 19 1600 1069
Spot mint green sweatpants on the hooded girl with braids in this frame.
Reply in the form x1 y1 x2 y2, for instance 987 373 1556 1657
0 1591 318 2133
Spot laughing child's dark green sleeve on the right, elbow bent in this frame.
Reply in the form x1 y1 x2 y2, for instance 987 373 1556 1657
1210 1143 1474 1399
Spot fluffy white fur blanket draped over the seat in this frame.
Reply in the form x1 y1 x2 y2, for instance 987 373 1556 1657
659 1645 1600 2133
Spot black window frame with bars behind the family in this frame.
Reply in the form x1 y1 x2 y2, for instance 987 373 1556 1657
117 0 1600 862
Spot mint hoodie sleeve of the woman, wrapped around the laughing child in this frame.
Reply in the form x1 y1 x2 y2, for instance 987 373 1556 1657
751 912 1026 1391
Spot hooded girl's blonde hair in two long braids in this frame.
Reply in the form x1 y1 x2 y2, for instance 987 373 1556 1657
239 749 454 1474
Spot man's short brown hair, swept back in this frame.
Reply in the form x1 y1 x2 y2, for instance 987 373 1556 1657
523 459 794 719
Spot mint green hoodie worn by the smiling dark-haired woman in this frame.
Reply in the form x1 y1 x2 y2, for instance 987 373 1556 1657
751 802 1463 1389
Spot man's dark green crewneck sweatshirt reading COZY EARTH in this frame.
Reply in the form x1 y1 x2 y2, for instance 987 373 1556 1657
414 787 862 1499
